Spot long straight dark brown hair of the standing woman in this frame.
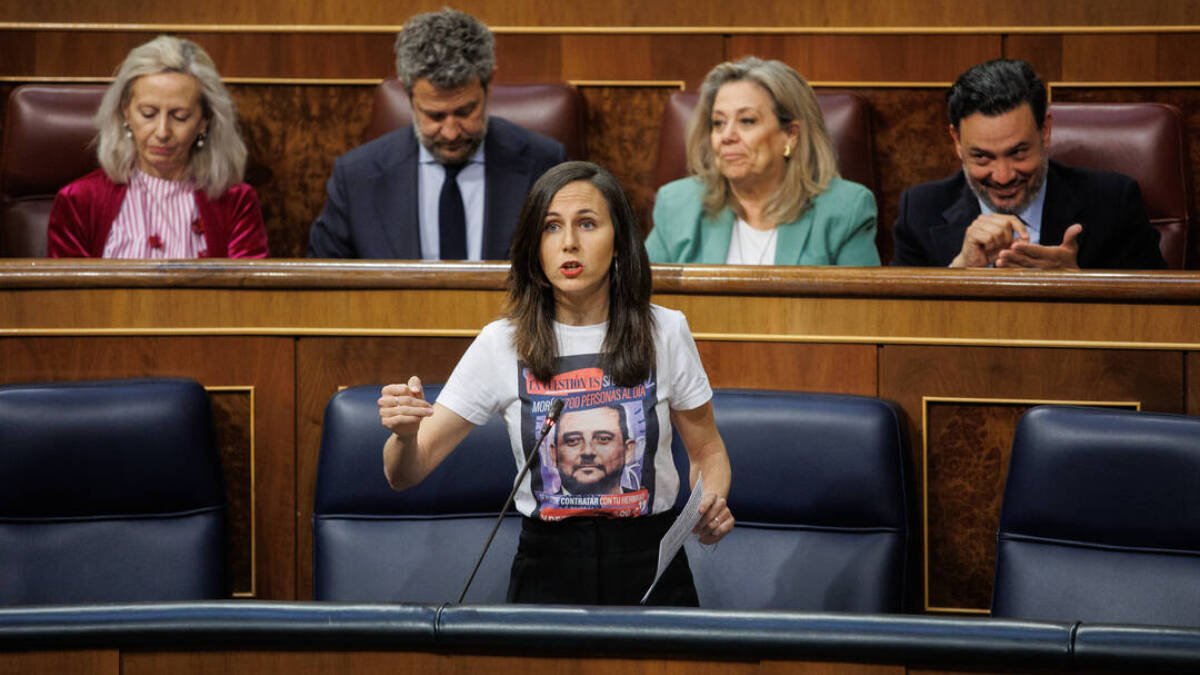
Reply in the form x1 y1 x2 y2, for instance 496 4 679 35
509 162 654 387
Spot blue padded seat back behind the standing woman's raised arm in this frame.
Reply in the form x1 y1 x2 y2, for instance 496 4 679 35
313 386 521 603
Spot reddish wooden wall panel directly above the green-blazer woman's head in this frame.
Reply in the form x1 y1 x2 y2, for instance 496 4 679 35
728 35 1001 83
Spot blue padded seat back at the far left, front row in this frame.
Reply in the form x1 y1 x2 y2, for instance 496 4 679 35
0 378 227 604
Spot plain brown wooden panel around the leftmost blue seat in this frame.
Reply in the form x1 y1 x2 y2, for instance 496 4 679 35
0 336 295 599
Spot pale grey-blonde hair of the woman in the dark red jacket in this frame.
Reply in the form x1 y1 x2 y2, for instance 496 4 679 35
95 35 246 199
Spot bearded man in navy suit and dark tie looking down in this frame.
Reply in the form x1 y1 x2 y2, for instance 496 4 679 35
308 8 566 261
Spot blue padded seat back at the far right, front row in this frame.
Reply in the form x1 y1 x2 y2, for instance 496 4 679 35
992 406 1200 626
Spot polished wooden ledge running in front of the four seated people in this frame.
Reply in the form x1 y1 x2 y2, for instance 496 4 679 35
9 258 1200 296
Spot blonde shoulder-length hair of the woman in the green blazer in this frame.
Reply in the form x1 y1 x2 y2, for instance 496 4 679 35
688 56 838 225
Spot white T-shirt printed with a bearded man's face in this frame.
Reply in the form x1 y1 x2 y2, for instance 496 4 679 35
437 305 713 520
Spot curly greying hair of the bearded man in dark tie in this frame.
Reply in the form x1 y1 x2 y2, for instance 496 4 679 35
396 7 496 94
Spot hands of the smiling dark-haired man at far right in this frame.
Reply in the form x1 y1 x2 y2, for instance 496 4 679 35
950 214 1084 269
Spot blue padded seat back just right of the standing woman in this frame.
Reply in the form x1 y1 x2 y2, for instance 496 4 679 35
676 389 908 613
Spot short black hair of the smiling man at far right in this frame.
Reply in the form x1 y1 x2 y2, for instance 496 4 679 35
946 59 1046 131
